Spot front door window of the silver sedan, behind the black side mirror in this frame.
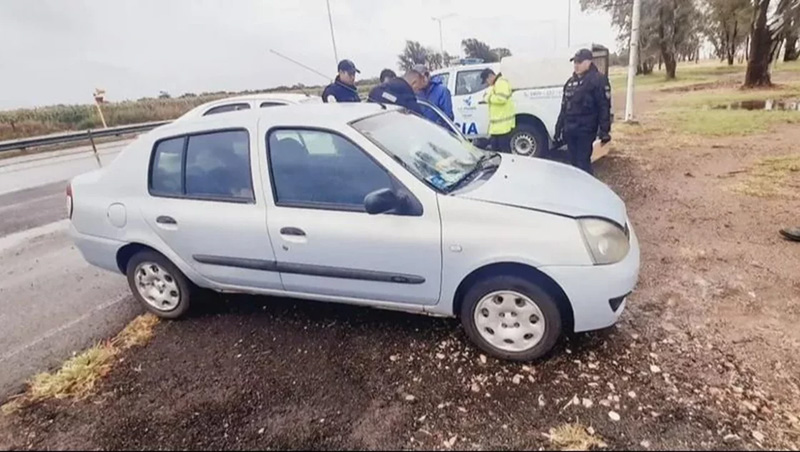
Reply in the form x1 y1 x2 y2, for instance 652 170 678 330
267 129 392 211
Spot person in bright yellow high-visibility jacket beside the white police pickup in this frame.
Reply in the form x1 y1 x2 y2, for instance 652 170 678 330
481 68 517 153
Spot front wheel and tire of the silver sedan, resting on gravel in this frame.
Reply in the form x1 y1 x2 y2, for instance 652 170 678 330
460 276 562 361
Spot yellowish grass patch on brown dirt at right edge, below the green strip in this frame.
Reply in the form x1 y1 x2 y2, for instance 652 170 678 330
733 155 800 198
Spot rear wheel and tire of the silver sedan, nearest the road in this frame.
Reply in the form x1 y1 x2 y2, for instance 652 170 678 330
126 250 196 320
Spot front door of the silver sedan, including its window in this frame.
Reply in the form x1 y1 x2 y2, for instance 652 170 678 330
265 128 442 305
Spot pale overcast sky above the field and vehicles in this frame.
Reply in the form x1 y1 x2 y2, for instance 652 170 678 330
0 0 617 109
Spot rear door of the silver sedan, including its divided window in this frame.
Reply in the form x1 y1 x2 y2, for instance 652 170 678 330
142 121 282 290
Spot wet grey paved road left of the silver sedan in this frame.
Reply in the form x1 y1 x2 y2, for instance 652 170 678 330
0 143 139 399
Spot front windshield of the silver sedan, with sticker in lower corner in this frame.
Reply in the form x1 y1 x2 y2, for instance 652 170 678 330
352 110 489 191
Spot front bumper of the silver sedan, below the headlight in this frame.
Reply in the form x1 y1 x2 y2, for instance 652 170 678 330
540 223 639 333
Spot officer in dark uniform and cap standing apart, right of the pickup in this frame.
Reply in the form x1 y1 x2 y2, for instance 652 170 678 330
555 49 611 174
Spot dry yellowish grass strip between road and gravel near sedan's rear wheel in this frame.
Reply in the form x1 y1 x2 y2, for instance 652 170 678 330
2 314 158 415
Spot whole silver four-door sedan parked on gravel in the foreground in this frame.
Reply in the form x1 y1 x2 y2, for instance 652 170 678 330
68 104 639 360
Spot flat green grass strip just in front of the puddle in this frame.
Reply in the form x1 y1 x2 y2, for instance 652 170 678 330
660 108 800 137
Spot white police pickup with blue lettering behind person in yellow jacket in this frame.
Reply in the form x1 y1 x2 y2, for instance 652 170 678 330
432 45 608 157
